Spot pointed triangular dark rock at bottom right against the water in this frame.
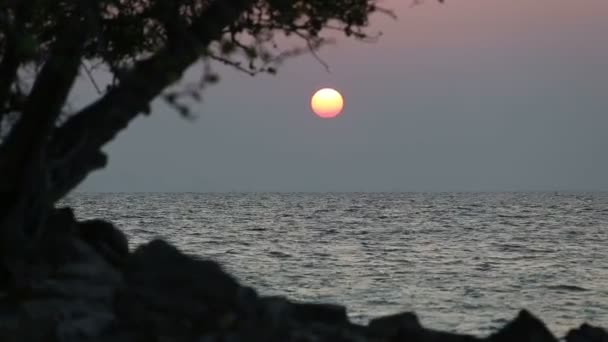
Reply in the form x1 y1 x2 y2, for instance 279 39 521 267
486 310 557 342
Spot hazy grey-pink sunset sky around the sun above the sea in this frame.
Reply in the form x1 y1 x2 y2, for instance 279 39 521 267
74 0 608 192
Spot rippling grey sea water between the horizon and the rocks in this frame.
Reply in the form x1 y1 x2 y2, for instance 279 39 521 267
64 193 608 335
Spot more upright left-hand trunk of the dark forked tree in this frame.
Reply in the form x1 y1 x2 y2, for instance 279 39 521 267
0 14 87 284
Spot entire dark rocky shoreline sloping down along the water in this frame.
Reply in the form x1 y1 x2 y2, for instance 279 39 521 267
0 209 608 342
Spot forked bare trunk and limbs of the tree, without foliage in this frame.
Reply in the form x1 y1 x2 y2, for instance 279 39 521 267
0 0 255 286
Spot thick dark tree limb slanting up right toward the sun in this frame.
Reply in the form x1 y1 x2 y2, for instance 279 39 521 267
51 0 255 200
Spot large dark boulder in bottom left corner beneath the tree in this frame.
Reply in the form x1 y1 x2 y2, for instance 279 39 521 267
0 233 124 342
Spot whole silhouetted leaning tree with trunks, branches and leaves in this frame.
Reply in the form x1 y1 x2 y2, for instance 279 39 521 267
0 0 436 282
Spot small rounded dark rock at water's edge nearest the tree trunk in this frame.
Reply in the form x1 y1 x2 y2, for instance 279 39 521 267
78 220 129 266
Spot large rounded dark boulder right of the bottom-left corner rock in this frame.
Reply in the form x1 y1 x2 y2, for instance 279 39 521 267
115 240 246 336
